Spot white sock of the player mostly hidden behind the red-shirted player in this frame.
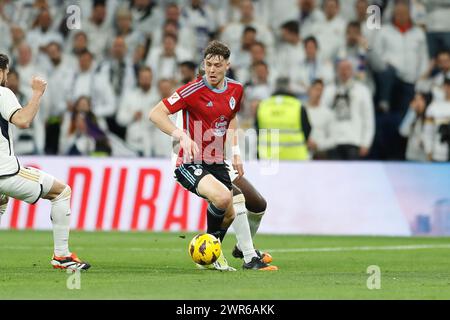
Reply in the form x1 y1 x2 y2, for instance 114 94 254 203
232 195 257 263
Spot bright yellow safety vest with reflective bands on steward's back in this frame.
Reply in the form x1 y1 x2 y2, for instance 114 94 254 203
257 95 309 160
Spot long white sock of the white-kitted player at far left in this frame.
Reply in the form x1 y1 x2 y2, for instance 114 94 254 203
51 186 71 257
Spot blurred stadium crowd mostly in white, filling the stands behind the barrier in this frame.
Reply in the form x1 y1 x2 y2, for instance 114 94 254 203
0 0 450 161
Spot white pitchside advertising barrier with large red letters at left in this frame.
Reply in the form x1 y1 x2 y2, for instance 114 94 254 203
0 157 450 236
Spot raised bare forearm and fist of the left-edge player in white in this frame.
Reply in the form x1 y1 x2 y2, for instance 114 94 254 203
10 77 47 129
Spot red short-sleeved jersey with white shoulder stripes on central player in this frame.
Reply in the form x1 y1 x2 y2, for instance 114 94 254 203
163 77 244 166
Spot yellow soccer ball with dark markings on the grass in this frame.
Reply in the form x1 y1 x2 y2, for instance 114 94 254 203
188 233 222 265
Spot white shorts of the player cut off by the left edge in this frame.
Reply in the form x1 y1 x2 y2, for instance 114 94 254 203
0 166 55 204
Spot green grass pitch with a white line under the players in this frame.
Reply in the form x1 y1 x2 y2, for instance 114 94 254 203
0 231 450 300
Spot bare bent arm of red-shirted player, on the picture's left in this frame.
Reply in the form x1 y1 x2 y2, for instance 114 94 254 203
149 101 199 159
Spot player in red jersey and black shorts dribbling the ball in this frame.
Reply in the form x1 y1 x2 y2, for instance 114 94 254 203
149 41 276 271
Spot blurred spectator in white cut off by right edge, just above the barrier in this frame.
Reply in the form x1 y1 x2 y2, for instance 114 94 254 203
424 78 450 162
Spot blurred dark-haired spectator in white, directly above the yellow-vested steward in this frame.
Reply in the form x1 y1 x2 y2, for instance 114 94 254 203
277 21 305 78
